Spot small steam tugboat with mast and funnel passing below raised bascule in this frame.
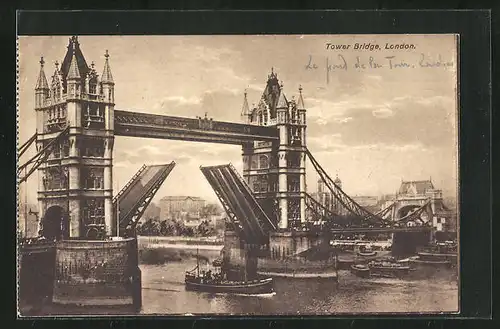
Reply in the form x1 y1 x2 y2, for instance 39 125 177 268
184 250 274 295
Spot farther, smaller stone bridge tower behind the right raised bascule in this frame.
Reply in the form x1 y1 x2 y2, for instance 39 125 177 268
242 70 306 228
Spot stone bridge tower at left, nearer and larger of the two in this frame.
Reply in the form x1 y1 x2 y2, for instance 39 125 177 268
35 36 116 239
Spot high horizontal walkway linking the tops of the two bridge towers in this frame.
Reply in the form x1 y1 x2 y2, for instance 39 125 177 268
114 110 279 145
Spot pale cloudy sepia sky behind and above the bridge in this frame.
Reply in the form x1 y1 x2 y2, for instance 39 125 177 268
18 35 458 203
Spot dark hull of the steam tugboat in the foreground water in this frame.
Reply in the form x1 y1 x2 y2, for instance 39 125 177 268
185 279 274 295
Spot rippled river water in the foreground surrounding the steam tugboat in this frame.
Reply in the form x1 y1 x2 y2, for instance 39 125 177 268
141 260 458 315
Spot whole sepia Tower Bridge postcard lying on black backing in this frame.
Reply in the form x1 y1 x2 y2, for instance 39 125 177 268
17 34 460 317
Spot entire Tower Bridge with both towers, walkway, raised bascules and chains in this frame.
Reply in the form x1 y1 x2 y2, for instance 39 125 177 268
18 37 456 303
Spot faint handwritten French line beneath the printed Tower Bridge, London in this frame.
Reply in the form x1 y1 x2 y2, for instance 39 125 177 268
305 54 455 82
